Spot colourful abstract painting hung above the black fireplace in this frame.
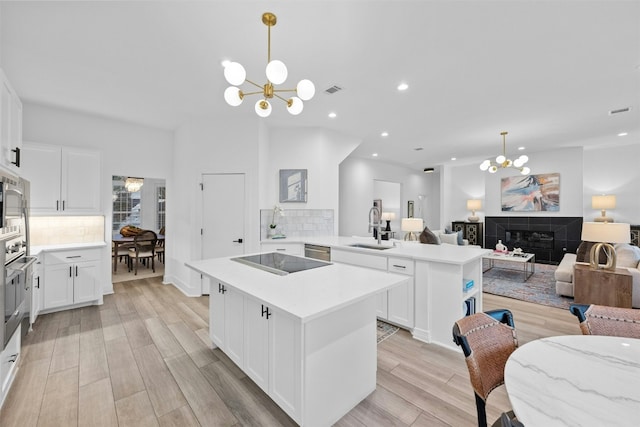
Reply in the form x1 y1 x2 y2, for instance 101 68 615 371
500 173 560 212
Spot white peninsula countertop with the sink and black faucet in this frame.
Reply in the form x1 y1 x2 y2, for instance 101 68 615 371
262 236 492 264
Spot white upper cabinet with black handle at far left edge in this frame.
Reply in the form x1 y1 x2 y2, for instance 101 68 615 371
0 70 22 172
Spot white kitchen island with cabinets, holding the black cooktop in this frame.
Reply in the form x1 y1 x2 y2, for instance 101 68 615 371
186 254 408 426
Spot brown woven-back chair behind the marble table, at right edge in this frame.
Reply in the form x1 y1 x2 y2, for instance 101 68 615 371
569 304 640 338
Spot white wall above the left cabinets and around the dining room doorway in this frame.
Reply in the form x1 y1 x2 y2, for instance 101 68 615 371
22 101 173 293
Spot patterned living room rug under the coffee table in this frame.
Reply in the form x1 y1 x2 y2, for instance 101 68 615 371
482 260 573 309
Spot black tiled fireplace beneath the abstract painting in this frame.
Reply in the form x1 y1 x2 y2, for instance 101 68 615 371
485 216 582 264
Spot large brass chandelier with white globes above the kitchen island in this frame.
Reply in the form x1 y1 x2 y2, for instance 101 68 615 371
224 12 316 117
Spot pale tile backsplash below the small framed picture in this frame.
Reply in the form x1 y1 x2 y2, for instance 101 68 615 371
260 209 334 239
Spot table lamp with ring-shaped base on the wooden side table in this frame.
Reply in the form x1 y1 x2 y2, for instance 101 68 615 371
582 222 631 270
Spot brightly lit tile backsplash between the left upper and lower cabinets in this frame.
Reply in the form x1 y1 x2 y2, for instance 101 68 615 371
29 216 104 246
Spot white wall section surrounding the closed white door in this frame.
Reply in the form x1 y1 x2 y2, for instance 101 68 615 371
170 111 260 295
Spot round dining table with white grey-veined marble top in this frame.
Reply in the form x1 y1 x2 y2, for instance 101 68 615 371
504 335 640 427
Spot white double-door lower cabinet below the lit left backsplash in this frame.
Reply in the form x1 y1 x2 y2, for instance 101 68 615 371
41 249 101 310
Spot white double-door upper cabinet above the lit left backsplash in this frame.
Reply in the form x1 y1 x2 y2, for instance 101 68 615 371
21 142 102 215
